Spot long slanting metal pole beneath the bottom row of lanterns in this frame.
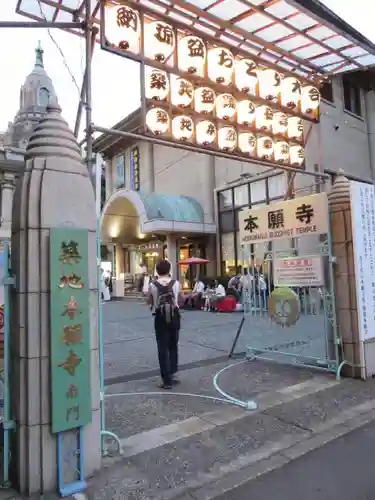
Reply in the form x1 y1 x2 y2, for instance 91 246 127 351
92 124 329 178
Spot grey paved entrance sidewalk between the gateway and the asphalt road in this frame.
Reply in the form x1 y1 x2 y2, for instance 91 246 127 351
83 362 375 500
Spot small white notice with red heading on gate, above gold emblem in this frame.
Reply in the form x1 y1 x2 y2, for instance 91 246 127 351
274 257 324 287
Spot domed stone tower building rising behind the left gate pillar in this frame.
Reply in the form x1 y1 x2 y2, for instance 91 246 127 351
0 44 57 240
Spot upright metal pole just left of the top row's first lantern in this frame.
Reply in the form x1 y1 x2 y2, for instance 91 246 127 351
85 0 93 176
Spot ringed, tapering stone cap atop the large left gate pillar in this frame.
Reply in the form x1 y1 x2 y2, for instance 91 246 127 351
26 102 82 163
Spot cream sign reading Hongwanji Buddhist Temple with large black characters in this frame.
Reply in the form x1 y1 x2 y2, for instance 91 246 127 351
239 193 329 245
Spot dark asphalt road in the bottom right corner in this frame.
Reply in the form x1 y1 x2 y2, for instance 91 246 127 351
216 423 375 500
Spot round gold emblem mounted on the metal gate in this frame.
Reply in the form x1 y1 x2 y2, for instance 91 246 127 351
268 288 301 326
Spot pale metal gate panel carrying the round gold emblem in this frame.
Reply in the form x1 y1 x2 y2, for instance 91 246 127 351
241 197 341 374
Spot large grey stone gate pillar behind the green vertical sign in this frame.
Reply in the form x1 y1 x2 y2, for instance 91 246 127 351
11 105 101 494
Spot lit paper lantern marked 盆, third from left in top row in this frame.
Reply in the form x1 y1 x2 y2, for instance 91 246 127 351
178 36 207 77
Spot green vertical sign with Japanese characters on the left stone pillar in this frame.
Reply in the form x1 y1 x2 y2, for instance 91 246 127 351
50 228 92 433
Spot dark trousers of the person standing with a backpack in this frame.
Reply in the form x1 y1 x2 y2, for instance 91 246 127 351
155 315 180 385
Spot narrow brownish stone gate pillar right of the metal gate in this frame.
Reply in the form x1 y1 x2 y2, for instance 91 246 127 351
328 170 364 377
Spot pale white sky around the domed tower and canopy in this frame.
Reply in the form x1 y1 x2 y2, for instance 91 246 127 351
0 0 375 139
